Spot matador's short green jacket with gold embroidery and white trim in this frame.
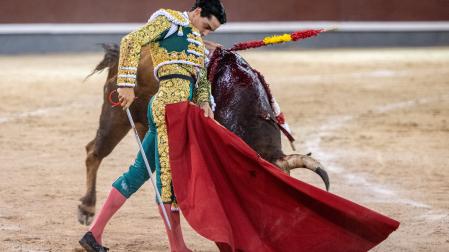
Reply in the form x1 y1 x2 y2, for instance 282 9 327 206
117 9 210 103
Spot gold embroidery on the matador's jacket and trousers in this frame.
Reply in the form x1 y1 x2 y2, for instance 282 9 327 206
118 9 210 205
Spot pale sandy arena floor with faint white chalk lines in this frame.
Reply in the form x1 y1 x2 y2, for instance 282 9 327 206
0 48 449 251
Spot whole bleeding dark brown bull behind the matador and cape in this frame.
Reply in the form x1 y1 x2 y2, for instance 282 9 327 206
78 45 329 225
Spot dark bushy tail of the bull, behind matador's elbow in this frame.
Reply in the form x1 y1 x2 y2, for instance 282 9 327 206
85 43 120 80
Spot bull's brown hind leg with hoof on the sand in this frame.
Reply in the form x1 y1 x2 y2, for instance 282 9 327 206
78 103 131 225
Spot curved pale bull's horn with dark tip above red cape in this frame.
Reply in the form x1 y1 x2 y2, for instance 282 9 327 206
273 154 330 191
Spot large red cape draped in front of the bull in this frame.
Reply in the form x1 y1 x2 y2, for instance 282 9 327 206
166 102 399 252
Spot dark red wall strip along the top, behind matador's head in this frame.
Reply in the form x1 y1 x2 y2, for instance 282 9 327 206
0 0 449 23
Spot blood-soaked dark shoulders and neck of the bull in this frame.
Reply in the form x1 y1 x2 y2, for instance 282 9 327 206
208 49 284 162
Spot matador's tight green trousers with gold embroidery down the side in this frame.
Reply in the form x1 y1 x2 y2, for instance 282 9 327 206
112 78 194 204
